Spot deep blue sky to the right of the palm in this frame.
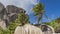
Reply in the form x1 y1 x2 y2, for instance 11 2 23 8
41 0 60 20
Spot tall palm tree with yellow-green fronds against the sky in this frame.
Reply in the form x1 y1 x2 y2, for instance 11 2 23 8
32 3 45 24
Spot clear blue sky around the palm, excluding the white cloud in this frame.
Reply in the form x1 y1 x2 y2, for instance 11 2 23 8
31 0 60 23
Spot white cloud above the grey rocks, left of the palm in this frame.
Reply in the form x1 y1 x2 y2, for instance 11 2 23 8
0 0 37 13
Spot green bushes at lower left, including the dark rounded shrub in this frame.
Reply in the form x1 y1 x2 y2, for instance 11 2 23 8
0 13 29 34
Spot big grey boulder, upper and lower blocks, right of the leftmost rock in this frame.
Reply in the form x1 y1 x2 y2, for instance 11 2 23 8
6 5 25 22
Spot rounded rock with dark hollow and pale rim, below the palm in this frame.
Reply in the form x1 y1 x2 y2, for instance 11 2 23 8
41 24 55 34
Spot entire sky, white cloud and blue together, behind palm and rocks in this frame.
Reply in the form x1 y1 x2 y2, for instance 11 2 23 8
0 0 60 23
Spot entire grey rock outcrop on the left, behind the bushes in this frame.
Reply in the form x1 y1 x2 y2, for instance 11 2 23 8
0 3 25 29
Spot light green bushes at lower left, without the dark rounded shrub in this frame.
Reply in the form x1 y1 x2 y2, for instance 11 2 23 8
0 15 22 34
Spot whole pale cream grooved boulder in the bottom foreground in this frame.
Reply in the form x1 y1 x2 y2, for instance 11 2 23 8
14 24 43 34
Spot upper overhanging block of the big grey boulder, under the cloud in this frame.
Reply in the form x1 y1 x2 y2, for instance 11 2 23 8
6 5 25 14
